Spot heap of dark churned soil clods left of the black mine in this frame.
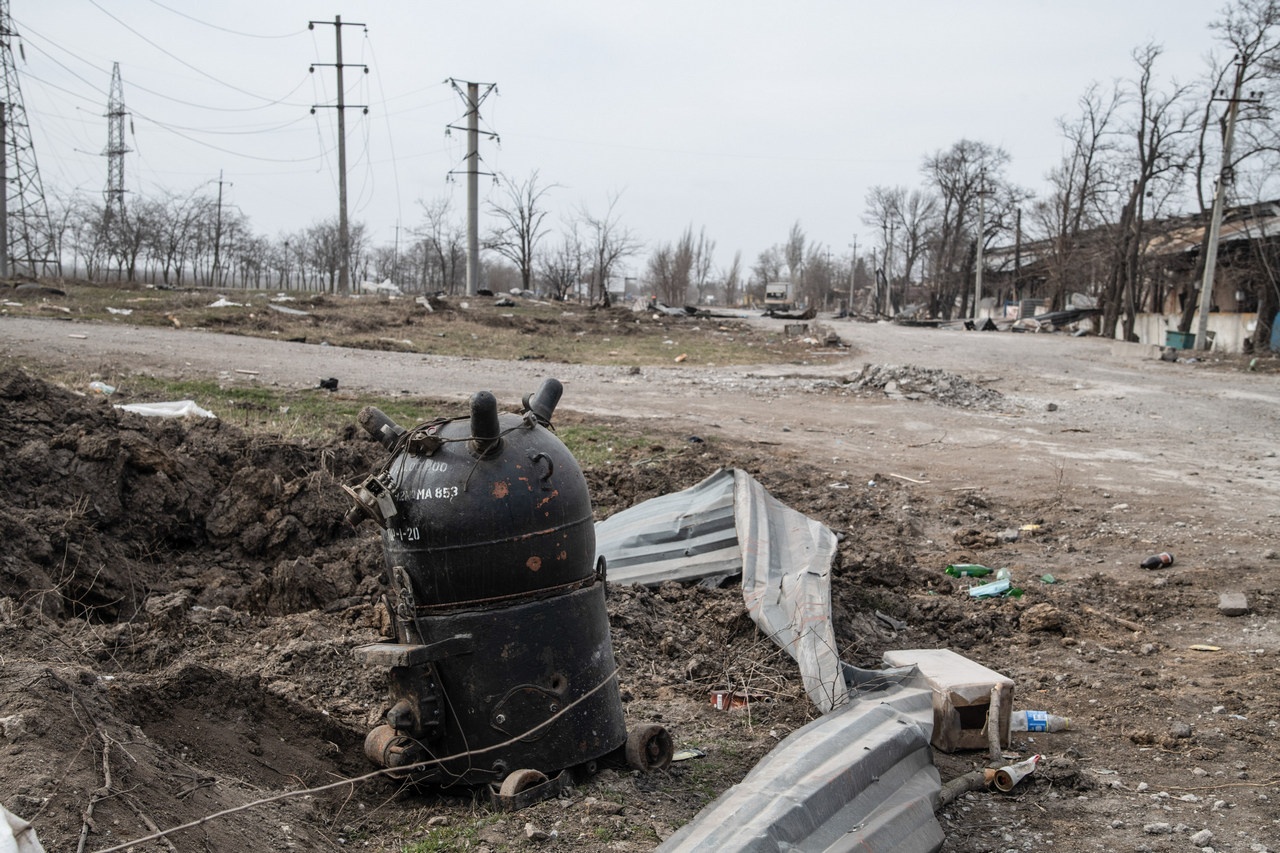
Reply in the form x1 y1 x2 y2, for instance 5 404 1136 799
0 370 378 622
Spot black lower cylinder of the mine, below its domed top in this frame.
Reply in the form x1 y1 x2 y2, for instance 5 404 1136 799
399 580 627 784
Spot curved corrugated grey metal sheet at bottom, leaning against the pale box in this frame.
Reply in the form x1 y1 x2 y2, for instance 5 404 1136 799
658 667 943 853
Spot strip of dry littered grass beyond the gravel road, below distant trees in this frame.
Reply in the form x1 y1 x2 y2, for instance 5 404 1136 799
0 282 813 366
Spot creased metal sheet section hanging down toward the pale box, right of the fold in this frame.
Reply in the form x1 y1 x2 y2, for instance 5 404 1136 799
733 471 849 713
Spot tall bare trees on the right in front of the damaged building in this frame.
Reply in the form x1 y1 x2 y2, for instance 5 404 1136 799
839 0 1280 345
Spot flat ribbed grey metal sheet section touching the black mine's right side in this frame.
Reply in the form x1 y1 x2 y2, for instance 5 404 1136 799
595 470 742 584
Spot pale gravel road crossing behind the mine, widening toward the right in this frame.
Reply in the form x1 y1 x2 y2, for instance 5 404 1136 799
0 318 1280 520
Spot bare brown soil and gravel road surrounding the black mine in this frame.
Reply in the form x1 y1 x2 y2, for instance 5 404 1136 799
0 297 1280 852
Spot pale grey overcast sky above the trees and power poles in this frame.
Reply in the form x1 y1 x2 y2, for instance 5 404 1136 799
10 0 1222 269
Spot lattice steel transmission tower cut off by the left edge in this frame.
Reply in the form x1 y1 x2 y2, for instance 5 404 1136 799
0 0 60 275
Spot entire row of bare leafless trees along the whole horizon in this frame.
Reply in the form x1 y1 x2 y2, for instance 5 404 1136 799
35 0 1280 338
